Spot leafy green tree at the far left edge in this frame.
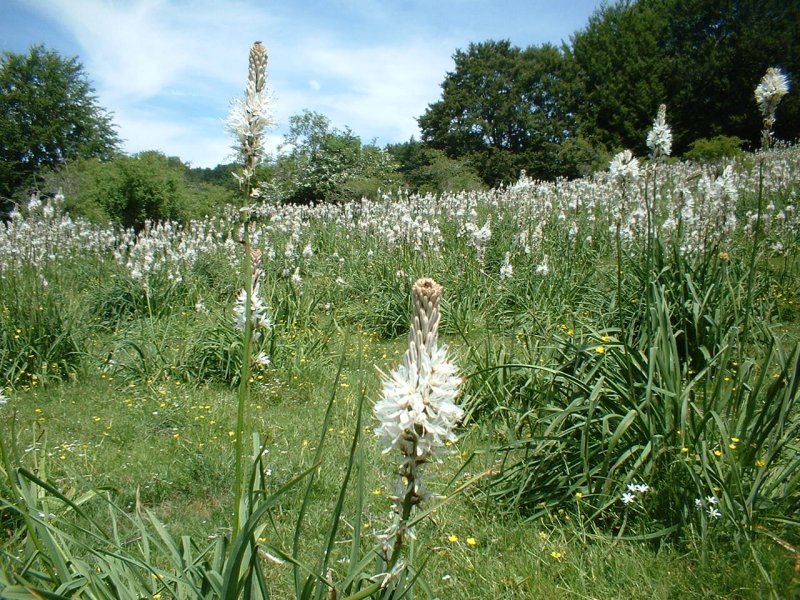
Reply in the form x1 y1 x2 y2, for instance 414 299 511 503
0 46 119 210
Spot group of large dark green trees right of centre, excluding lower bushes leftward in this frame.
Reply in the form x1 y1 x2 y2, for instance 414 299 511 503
419 0 800 185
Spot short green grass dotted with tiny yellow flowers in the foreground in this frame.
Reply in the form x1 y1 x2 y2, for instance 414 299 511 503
3 326 797 598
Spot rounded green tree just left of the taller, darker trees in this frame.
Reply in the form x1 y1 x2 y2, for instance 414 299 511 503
418 40 573 185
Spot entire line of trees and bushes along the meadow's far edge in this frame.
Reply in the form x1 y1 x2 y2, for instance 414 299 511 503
0 0 800 226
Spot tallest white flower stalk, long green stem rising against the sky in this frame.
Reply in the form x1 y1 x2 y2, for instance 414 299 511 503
227 42 273 538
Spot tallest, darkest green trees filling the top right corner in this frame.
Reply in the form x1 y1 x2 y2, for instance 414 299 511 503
570 0 800 154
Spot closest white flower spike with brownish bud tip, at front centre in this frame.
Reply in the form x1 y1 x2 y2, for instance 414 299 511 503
374 278 464 572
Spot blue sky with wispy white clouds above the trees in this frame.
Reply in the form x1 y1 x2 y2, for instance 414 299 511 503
0 0 601 167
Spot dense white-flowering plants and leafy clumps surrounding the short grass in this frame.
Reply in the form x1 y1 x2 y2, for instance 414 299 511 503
0 147 800 596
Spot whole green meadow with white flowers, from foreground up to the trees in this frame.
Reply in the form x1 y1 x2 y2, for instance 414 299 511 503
0 146 800 599
